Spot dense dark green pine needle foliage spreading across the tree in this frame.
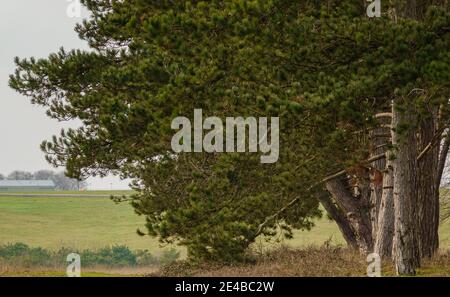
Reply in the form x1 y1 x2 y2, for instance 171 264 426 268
10 0 450 261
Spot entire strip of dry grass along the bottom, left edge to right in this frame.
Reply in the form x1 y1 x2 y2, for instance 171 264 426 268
0 246 450 277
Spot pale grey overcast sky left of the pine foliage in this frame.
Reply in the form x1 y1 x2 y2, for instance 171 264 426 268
0 0 128 189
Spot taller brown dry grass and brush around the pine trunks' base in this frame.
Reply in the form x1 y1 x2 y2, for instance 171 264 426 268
157 247 450 277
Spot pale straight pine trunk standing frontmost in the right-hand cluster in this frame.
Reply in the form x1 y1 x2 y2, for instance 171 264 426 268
392 99 420 275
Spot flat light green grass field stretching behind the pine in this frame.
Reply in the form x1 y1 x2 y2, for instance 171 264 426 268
0 191 450 254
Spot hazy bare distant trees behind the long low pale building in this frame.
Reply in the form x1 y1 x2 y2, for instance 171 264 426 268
0 170 87 191
